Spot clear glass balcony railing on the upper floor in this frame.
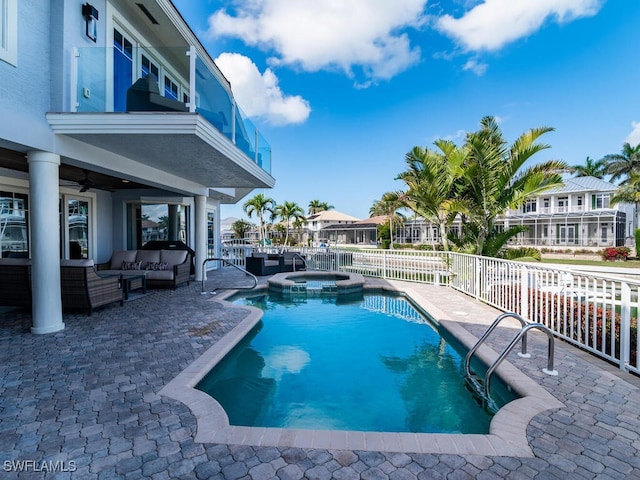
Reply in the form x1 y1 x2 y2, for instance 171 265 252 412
69 47 271 173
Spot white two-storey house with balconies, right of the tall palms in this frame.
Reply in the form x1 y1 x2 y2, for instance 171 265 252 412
399 177 637 249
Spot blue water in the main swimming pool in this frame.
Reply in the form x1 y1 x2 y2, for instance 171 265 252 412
197 293 512 433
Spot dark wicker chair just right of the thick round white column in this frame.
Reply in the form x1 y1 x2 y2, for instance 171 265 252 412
60 260 124 315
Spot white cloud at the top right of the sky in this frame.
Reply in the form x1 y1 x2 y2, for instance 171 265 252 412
436 0 603 51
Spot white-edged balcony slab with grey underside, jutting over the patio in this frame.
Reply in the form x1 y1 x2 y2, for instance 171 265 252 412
47 112 275 195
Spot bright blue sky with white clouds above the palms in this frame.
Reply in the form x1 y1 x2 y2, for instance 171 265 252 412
173 0 640 218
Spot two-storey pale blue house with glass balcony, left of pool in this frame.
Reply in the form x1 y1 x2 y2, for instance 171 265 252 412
0 0 275 333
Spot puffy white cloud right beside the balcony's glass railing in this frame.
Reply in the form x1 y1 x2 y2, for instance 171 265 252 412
215 53 311 125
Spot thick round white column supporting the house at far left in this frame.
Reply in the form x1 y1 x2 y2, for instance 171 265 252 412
27 151 64 333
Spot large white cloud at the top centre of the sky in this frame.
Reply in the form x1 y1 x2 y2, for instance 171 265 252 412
209 0 426 80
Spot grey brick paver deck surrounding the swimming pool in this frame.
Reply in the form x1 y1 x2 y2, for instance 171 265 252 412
0 268 640 480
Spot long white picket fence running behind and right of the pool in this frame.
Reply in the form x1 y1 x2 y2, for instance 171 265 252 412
221 248 640 374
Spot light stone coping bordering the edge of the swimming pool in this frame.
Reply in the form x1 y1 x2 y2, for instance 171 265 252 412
158 286 564 457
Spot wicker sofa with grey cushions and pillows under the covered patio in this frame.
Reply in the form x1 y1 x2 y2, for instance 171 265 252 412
98 250 191 289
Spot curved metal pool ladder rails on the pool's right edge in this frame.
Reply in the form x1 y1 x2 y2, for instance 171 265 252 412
464 312 558 399
